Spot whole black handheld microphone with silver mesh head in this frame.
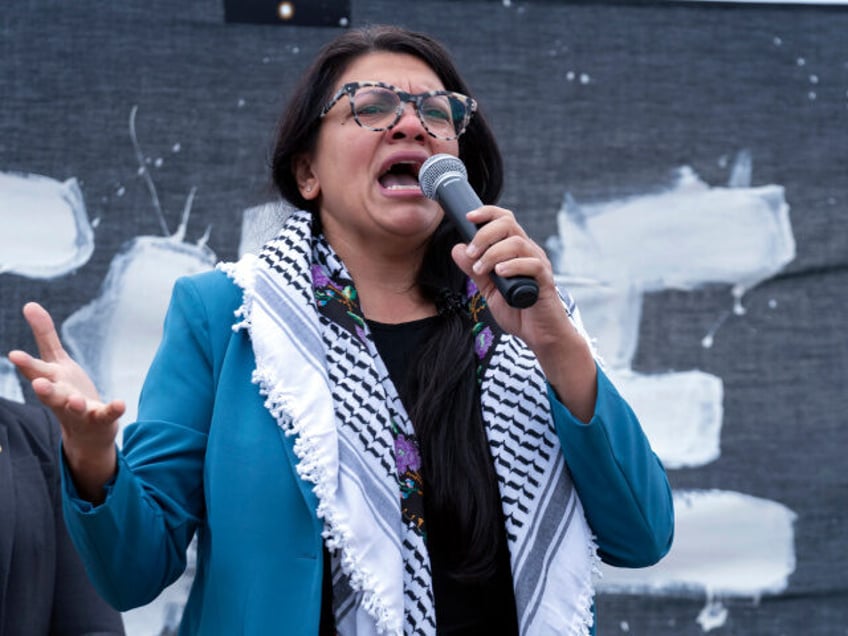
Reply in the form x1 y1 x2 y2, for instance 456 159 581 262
418 153 539 309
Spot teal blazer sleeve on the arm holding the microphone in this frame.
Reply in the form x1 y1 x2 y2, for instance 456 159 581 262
548 367 674 567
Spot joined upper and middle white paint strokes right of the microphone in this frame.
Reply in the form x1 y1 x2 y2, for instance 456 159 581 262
548 152 795 468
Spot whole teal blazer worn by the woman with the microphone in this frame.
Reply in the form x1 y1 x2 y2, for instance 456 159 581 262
63 271 674 636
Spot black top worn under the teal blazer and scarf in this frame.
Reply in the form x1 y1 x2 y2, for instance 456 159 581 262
320 316 518 636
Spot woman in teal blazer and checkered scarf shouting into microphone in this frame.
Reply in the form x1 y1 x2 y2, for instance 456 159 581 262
10 27 673 635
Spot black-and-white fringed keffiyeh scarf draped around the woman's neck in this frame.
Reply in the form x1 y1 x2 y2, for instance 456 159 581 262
220 212 597 636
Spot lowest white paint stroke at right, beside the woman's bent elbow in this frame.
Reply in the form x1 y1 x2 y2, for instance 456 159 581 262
598 490 796 599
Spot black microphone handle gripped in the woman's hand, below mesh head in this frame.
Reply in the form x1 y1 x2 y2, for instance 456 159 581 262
436 177 539 309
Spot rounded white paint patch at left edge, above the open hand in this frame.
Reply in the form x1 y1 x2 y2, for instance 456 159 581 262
0 172 94 279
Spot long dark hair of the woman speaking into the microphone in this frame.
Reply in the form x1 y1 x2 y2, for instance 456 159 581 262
272 26 503 580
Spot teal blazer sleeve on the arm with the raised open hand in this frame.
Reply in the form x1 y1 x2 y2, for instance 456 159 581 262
62 277 225 611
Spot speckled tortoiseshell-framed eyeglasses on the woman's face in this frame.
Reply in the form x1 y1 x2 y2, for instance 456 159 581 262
321 82 477 140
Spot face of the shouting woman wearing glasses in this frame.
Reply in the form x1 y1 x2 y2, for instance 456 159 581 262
296 52 459 253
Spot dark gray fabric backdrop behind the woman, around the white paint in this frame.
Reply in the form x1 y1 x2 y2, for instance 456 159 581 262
0 0 848 636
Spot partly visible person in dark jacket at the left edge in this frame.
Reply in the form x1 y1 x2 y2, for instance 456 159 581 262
0 398 124 636
